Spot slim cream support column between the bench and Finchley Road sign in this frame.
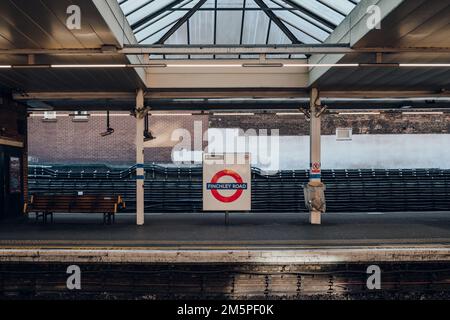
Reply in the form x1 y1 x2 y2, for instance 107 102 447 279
136 89 145 226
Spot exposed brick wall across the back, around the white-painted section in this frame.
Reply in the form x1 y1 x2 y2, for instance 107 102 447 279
28 112 450 165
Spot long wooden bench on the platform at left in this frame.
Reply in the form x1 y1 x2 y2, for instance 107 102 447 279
23 195 125 224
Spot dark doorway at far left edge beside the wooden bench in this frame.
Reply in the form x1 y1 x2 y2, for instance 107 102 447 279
0 146 23 219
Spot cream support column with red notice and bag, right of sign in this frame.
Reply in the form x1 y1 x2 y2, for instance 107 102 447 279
308 88 325 224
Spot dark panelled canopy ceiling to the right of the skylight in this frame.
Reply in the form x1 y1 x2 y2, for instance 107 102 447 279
316 0 450 93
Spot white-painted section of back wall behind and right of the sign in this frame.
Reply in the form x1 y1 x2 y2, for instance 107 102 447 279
171 129 450 170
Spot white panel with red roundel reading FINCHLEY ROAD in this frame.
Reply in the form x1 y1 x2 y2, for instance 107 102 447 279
203 153 252 213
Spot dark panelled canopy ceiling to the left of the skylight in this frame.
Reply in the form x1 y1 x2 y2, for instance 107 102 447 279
0 0 142 91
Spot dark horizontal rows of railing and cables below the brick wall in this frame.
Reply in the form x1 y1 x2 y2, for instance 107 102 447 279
29 165 450 213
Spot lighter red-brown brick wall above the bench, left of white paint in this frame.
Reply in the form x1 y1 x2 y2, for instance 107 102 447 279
28 112 208 165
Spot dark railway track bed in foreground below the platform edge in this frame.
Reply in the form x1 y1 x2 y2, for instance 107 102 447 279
0 262 450 300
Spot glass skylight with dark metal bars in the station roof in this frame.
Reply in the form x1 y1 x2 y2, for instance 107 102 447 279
118 0 359 58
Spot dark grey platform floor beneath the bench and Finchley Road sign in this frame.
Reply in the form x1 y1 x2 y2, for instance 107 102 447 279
0 212 450 250
